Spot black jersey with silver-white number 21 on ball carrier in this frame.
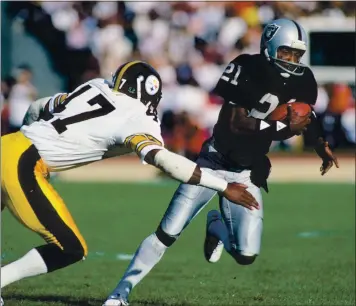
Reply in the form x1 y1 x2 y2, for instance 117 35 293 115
213 54 317 166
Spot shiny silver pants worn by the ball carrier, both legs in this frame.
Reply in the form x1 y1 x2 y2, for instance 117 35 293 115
161 139 263 256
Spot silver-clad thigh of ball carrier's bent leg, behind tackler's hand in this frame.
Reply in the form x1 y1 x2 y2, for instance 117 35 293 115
220 183 263 256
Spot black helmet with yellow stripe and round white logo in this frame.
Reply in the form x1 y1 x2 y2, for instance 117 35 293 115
112 61 162 108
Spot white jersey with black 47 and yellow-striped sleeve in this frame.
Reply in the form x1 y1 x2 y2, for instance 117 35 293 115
21 79 163 171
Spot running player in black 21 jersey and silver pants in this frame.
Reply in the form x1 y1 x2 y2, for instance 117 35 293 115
104 19 338 306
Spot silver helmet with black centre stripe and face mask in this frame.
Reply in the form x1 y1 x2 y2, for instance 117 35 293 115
261 18 307 77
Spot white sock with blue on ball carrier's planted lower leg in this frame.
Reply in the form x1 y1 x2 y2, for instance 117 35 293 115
112 233 167 297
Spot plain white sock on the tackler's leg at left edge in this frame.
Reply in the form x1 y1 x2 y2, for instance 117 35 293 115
1 249 47 288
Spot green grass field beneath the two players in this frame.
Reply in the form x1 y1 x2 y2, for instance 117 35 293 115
2 182 355 306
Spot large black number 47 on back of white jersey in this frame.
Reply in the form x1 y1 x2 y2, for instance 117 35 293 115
46 85 115 134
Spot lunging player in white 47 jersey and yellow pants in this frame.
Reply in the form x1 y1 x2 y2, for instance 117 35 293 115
1 61 258 302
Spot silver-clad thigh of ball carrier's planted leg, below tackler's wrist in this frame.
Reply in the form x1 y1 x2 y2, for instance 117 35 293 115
160 184 216 236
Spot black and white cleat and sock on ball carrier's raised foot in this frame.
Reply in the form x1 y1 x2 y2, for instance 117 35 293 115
204 210 224 263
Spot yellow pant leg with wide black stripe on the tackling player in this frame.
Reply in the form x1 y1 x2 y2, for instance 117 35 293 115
1 133 87 254
